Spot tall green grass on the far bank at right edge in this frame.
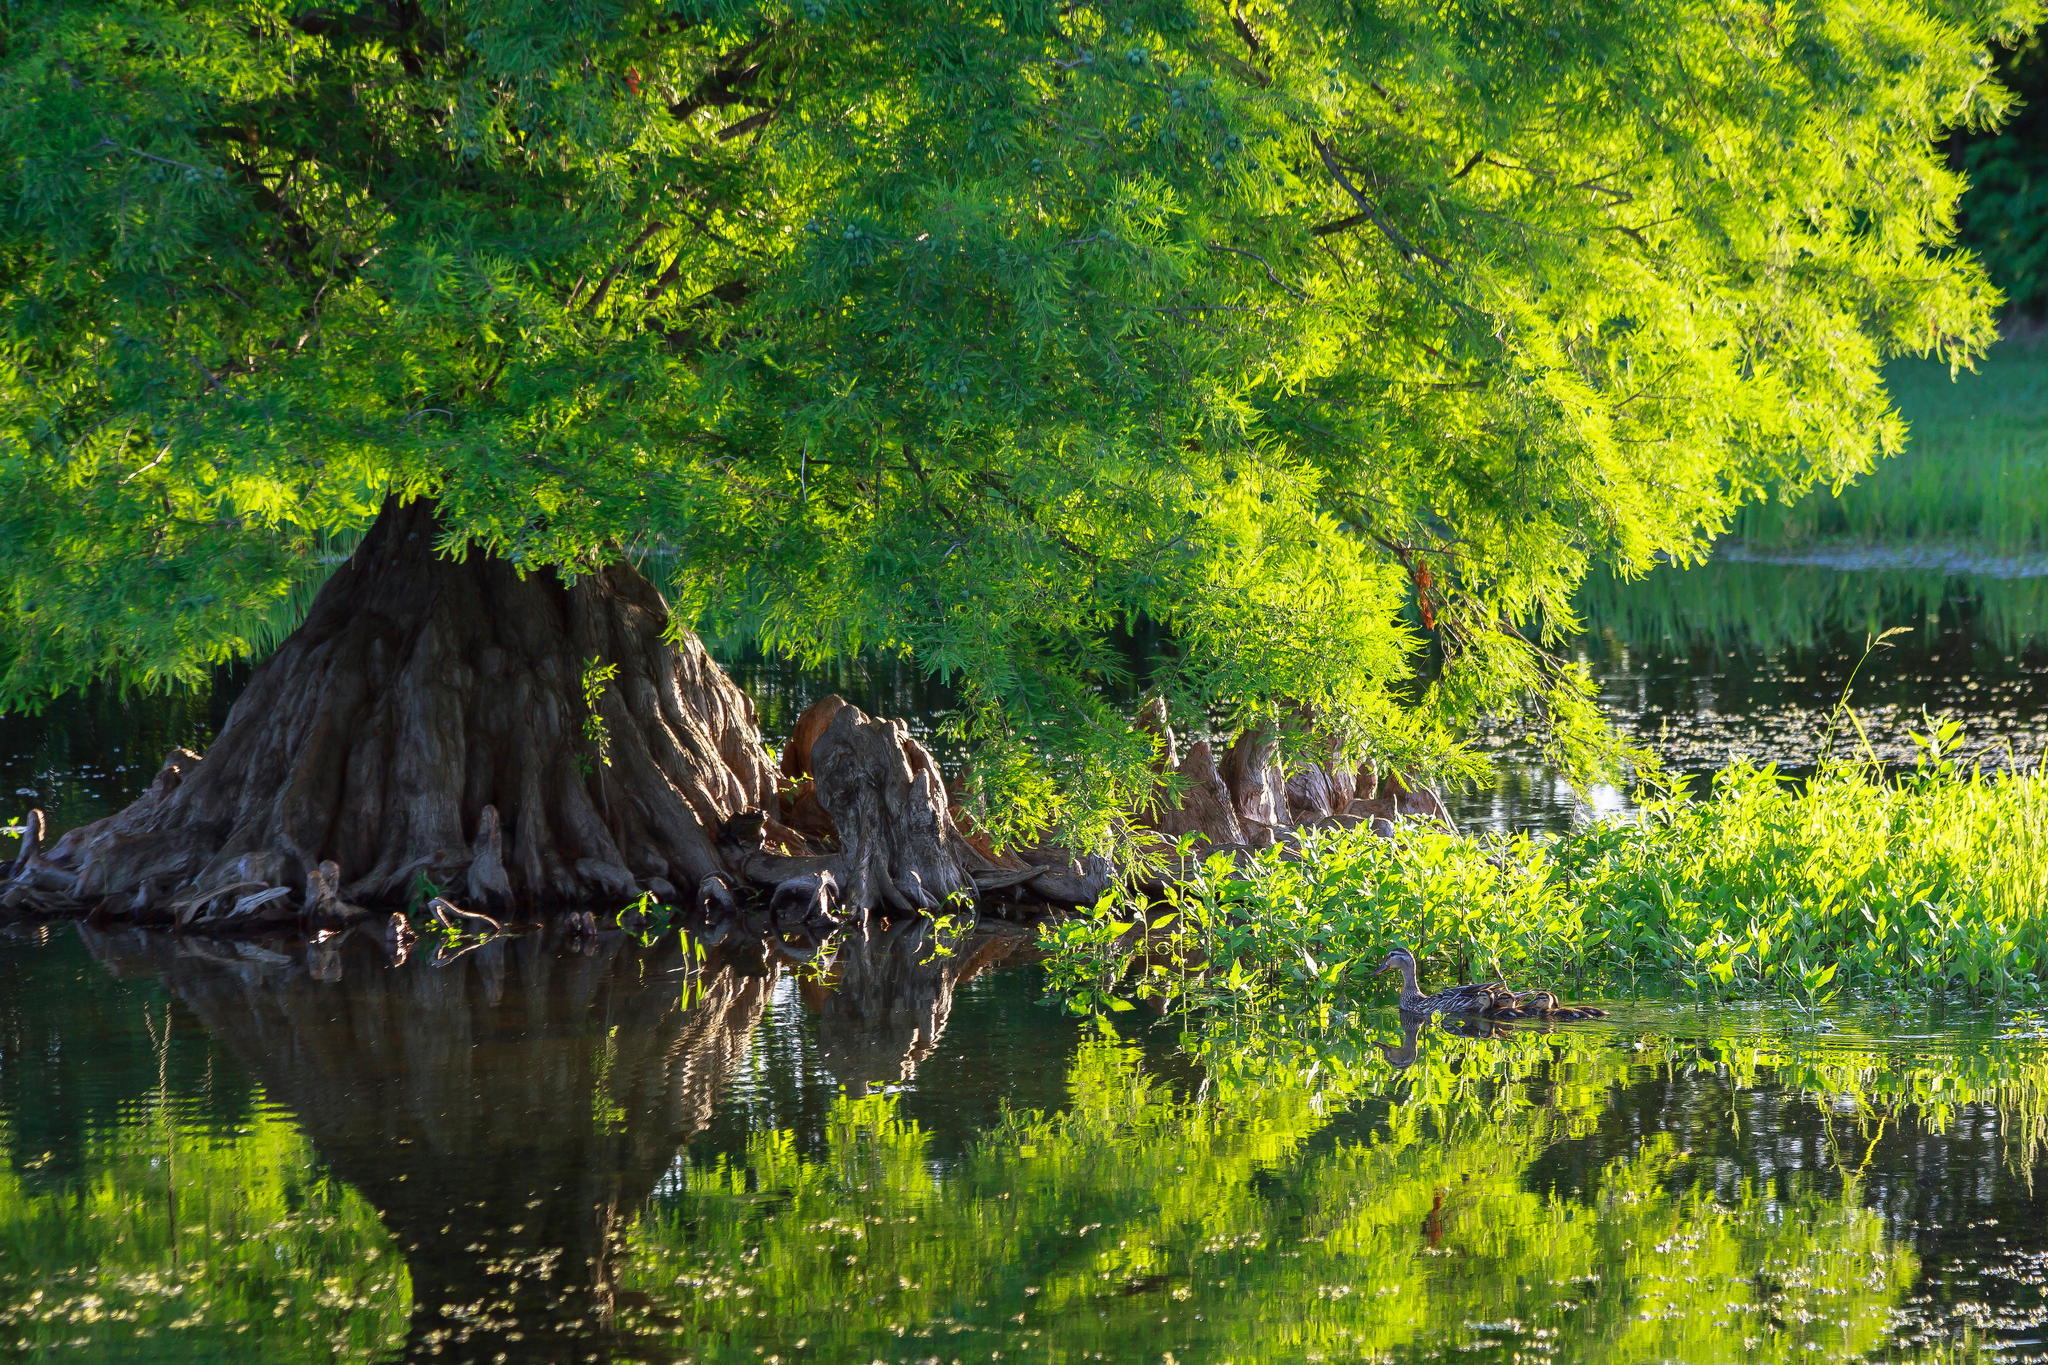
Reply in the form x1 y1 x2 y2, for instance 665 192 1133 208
1733 334 2048 553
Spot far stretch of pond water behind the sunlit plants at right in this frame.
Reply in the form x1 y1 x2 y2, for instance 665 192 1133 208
1452 559 2048 831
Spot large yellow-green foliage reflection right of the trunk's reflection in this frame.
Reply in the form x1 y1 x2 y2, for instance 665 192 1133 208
631 1040 1913 1361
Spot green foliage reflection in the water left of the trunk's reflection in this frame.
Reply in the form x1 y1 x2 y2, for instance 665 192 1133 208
0 1064 410 1361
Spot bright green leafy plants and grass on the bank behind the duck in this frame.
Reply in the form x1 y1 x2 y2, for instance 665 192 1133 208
1047 759 2048 1019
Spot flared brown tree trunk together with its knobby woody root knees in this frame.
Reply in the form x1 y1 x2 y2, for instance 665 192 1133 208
0 501 1448 937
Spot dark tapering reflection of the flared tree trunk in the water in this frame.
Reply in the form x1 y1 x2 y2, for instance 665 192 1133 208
75 931 772 1361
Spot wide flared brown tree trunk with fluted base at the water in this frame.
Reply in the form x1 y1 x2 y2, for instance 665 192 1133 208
10 501 776 923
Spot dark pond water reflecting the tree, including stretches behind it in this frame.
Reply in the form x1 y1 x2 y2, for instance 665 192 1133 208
0 561 2048 1363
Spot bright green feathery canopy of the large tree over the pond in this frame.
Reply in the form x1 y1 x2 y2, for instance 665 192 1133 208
0 0 2038 839
